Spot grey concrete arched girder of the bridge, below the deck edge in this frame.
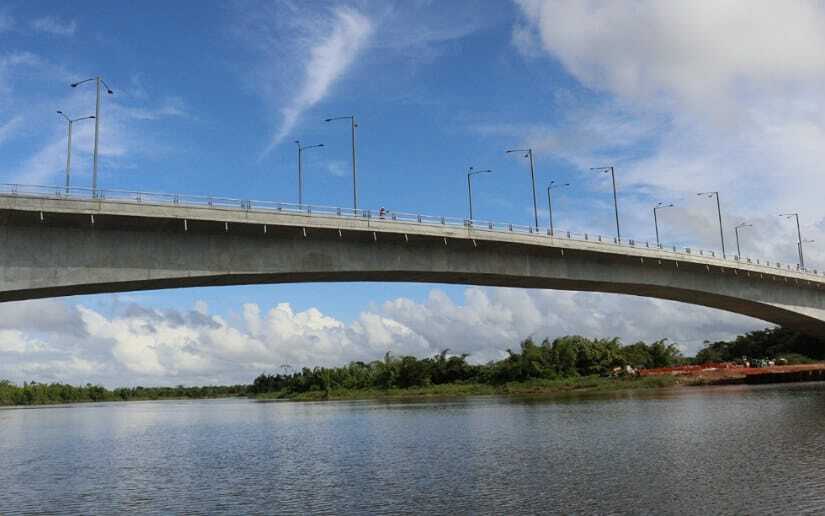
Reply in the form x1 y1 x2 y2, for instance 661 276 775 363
0 206 825 337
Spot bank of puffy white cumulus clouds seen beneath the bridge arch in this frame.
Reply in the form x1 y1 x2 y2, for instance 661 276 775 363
0 287 765 386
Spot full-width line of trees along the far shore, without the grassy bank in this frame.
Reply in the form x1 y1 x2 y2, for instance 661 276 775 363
0 328 825 405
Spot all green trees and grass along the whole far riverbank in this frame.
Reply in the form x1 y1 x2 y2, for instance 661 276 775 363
8 328 825 405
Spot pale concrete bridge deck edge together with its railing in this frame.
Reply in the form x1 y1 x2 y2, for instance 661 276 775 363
0 187 825 288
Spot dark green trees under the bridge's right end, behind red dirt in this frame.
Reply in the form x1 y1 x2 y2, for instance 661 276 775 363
695 328 825 364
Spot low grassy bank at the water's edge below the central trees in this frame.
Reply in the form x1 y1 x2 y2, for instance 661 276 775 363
255 376 679 401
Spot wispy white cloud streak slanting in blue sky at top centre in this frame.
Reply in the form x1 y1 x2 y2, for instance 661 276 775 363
270 7 373 147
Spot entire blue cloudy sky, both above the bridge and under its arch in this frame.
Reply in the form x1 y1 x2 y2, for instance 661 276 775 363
0 0 825 386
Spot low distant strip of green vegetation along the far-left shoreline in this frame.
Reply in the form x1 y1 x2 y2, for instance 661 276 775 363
0 380 249 405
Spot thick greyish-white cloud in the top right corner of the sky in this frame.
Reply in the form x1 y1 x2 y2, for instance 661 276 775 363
519 0 825 112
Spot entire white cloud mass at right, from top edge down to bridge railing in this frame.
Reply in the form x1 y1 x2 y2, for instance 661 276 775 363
510 0 825 268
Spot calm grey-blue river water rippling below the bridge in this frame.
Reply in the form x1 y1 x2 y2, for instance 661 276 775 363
0 383 825 514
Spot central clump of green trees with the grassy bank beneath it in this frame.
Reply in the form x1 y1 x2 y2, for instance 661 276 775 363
250 336 685 399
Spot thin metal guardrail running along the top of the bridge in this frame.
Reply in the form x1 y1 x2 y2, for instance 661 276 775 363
0 184 825 277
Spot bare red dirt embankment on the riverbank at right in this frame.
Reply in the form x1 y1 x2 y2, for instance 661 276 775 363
639 363 825 383
